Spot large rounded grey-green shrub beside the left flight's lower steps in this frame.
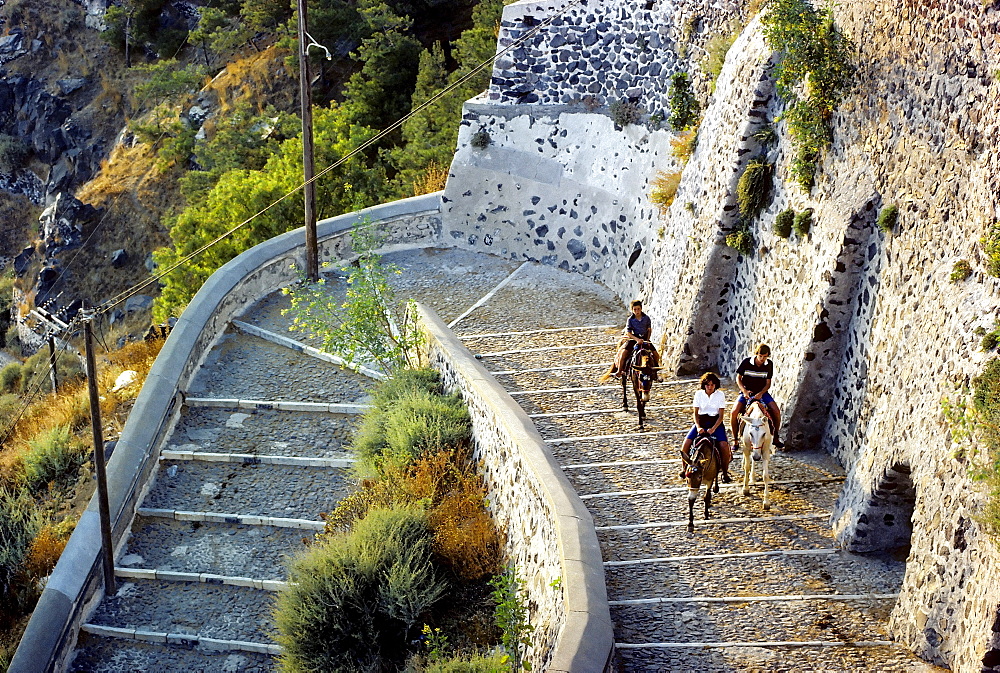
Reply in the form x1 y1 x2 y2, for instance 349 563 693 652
275 508 446 672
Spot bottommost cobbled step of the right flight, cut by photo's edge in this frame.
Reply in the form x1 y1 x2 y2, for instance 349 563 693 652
615 634 921 673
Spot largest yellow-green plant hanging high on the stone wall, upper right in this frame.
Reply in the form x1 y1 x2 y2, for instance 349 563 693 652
761 0 854 191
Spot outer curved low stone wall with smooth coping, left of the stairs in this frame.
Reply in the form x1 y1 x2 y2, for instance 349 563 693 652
9 192 441 673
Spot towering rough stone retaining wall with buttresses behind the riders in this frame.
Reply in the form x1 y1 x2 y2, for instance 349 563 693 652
444 0 1000 671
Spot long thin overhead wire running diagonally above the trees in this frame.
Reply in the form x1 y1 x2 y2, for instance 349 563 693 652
97 0 586 313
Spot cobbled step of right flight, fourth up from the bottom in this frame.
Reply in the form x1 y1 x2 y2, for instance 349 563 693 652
597 518 835 561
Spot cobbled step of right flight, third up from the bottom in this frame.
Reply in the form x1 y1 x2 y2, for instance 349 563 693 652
604 552 903 601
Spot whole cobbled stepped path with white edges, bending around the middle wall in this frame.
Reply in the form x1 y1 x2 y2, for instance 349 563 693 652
72 250 928 672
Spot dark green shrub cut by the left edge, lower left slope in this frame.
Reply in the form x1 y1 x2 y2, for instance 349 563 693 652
0 488 41 615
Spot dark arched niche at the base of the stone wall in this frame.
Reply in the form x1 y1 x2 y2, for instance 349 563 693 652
847 464 917 553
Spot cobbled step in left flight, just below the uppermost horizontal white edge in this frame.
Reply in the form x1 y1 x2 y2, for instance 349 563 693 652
166 407 360 458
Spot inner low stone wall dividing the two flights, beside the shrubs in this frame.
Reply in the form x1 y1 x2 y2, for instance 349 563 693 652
418 306 614 673
